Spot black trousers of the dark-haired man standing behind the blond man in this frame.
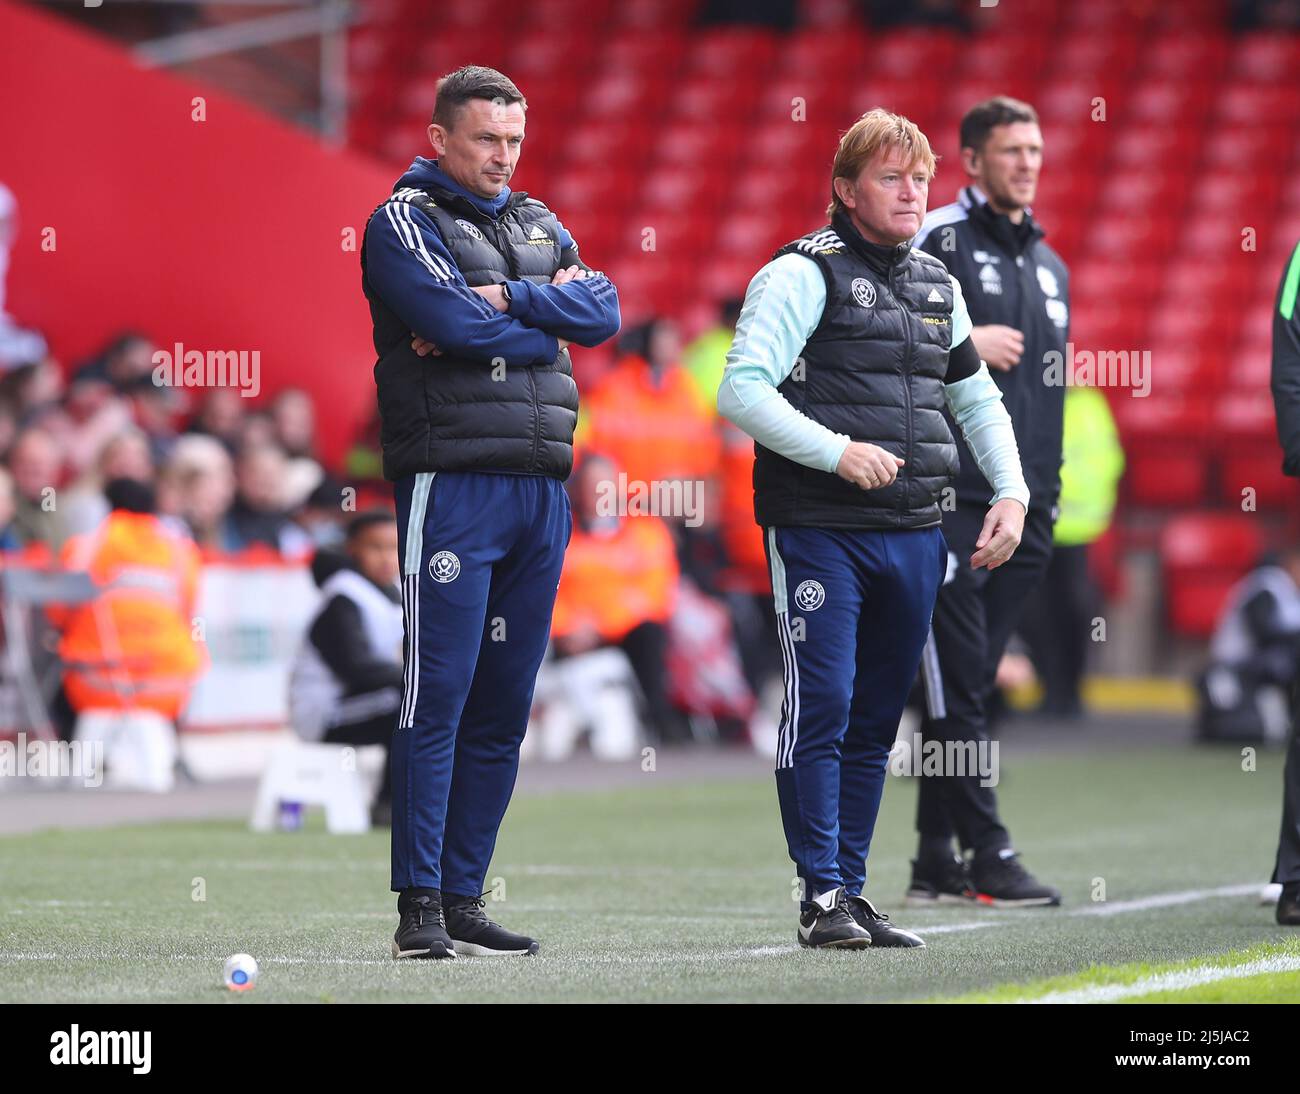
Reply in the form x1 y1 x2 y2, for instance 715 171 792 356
917 504 1052 851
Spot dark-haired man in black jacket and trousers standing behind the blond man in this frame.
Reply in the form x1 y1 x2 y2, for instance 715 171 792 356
907 96 1070 907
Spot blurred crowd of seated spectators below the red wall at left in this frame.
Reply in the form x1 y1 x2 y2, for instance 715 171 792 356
0 333 356 559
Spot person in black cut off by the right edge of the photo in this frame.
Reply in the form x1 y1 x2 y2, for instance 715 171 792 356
1273 239 1300 926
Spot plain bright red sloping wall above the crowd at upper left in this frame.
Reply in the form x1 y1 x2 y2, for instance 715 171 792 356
0 0 395 460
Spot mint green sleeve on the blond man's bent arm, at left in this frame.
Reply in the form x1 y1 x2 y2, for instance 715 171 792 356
718 255 849 473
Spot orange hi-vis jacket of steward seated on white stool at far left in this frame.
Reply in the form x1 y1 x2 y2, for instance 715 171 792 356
51 509 208 720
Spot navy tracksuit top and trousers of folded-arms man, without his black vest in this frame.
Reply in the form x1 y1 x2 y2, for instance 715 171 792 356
367 159 619 897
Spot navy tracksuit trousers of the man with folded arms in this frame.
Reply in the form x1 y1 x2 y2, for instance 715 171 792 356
391 472 573 897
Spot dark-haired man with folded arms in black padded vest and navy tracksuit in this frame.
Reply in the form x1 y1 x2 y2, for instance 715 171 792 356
361 66 619 958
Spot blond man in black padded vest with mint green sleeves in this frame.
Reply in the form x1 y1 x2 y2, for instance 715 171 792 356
718 110 1028 948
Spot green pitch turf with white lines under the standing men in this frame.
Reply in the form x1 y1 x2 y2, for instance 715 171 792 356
0 747 1300 1006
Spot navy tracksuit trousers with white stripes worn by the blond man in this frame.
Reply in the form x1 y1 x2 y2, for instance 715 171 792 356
763 525 948 908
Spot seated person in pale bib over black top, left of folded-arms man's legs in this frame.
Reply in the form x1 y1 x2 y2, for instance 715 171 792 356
289 509 403 824
